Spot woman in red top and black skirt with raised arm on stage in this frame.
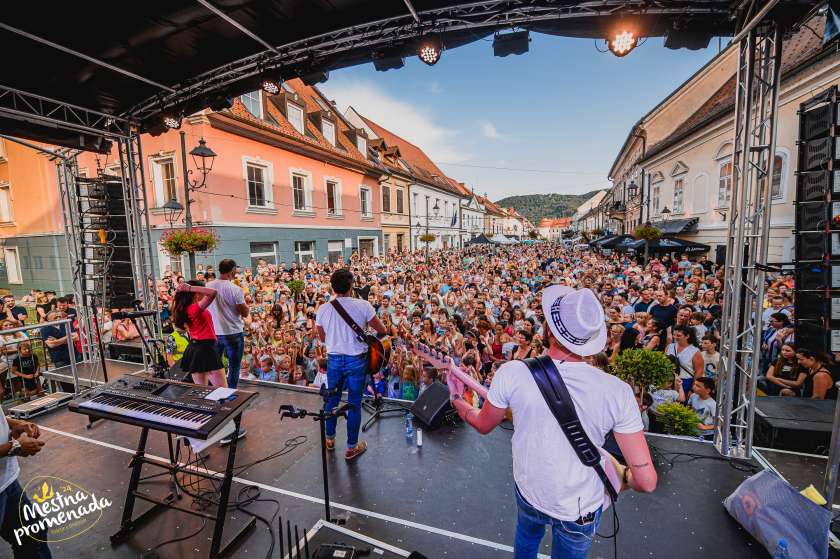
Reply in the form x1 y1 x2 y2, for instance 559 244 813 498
172 280 227 386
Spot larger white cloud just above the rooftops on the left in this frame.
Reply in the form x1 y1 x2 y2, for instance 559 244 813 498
322 80 470 162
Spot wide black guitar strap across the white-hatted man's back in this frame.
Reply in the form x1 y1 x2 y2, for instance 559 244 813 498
522 355 618 502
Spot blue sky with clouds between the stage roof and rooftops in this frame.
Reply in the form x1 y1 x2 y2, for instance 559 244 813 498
320 34 718 200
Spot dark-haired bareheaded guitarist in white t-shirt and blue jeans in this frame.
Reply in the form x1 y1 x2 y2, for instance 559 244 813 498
315 268 385 460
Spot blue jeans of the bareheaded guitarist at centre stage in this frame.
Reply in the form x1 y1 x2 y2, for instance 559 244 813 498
325 353 367 448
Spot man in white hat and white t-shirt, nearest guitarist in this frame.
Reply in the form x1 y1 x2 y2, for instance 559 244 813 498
448 285 656 559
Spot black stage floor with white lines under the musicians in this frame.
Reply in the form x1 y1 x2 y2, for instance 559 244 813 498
9 386 796 559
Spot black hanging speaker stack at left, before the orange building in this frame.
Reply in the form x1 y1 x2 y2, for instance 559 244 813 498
76 175 136 309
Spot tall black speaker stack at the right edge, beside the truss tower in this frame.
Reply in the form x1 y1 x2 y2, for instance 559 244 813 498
794 86 840 352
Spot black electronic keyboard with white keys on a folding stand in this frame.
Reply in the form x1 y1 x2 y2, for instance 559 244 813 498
69 375 257 439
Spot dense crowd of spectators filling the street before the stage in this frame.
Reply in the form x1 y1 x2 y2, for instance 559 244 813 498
0 243 837 430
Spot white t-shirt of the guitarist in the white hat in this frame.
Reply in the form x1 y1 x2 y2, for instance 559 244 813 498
487 360 643 521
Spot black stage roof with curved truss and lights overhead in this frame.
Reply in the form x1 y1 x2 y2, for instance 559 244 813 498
0 0 818 149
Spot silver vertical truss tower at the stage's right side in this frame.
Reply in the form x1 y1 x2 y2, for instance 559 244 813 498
715 22 783 458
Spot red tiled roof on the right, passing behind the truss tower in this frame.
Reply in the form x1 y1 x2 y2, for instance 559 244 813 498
646 16 825 157
